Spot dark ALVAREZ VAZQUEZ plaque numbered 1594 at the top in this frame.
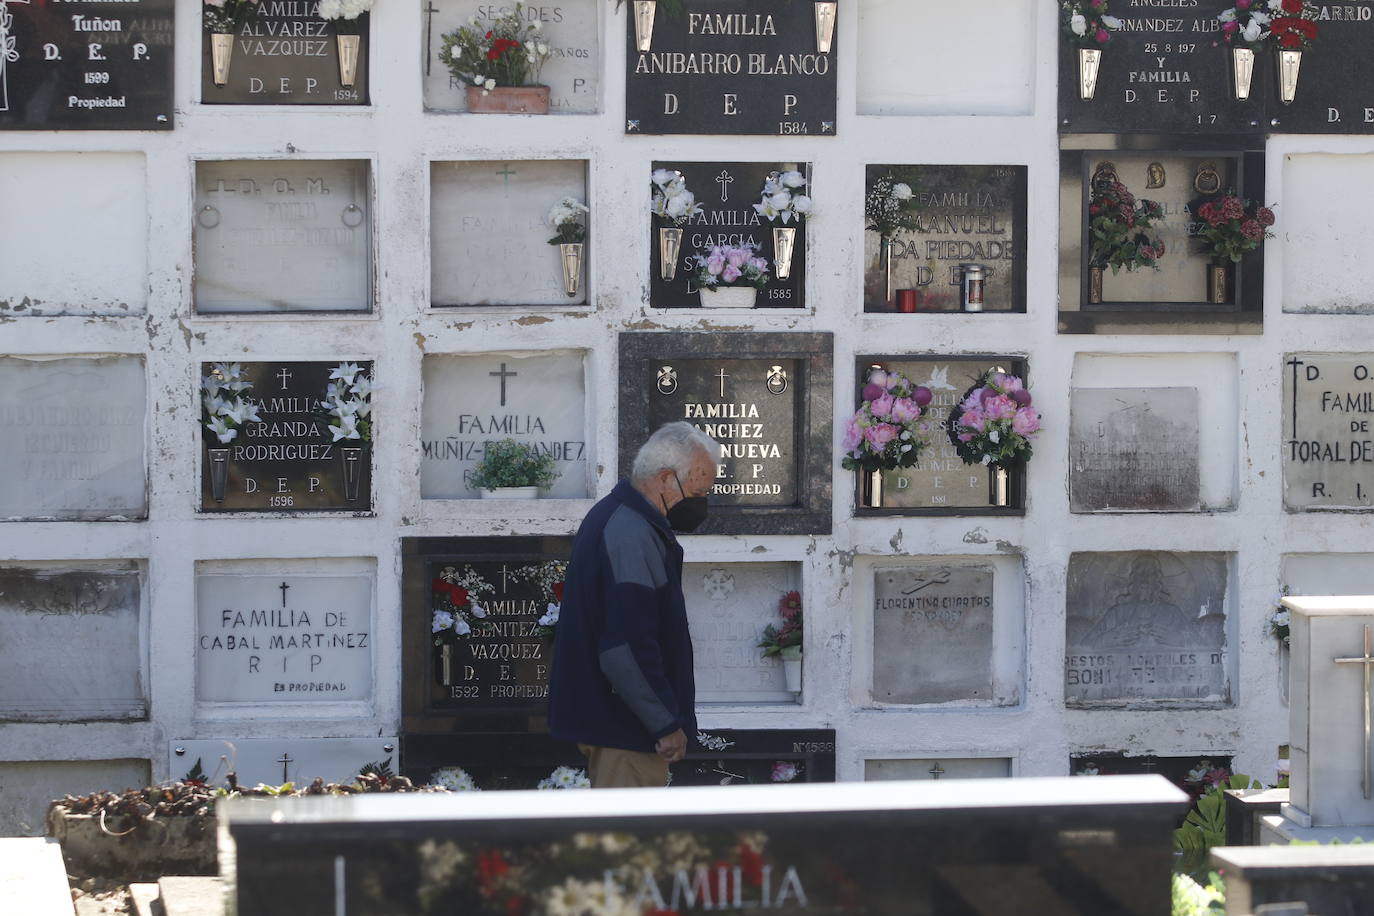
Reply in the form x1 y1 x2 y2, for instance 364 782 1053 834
201 0 371 104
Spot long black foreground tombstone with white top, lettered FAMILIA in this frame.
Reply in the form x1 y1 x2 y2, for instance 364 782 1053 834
220 776 1187 916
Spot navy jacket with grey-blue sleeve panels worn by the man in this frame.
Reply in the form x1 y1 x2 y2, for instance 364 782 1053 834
548 481 697 751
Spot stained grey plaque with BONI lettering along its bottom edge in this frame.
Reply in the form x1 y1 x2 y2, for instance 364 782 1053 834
1063 551 1231 706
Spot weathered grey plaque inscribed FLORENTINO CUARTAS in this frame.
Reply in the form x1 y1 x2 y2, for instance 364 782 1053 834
872 563 993 703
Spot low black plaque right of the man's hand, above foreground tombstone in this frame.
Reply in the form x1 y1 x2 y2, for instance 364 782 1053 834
669 728 835 786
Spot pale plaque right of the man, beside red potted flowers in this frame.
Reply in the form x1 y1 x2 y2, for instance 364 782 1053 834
683 563 805 703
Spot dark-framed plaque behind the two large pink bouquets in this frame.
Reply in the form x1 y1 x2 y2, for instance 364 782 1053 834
855 354 1033 516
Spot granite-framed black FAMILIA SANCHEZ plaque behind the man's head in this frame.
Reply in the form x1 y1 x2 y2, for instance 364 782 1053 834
620 332 833 534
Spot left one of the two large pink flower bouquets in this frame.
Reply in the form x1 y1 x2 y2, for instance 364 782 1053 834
841 367 930 471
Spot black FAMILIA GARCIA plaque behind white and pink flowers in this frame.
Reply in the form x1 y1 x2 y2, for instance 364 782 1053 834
649 162 811 309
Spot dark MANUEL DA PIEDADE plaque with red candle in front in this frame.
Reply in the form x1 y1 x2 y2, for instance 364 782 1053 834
863 165 1026 312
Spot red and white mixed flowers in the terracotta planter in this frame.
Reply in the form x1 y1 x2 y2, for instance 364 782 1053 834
438 3 552 95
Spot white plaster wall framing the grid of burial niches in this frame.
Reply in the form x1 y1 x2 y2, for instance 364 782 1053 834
0 0 1374 823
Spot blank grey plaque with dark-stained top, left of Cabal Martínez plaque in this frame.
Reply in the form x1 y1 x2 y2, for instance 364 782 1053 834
0 564 148 722
